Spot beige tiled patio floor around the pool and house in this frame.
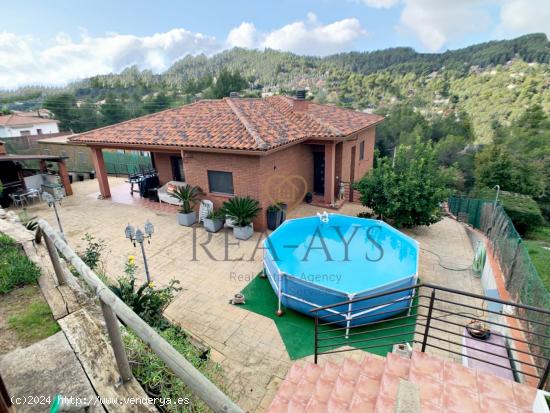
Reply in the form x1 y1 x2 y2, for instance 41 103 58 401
23 178 481 411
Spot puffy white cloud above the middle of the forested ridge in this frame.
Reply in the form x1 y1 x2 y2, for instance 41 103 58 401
227 13 366 56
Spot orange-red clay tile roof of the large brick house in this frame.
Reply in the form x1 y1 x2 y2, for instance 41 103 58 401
71 96 383 151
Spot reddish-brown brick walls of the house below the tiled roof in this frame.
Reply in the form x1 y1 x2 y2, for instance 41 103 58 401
148 128 380 231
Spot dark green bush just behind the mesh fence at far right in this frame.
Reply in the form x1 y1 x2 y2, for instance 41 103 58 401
470 188 544 235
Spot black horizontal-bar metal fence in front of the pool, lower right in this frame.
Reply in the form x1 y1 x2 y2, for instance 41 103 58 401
311 283 550 389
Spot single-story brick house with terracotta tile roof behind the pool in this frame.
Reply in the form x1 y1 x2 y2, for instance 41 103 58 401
70 96 383 229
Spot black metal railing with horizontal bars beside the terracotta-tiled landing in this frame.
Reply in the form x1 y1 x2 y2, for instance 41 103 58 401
310 283 550 389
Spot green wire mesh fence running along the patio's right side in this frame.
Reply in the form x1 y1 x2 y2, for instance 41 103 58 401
449 198 550 374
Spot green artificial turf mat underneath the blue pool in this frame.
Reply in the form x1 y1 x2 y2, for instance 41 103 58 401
242 276 416 360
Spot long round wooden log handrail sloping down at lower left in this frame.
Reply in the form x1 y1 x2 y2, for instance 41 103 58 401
38 219 242 413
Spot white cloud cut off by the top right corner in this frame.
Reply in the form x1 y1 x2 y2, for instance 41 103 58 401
497 0 550 36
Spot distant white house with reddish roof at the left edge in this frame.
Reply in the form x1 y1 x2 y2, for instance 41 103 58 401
0 114 59 139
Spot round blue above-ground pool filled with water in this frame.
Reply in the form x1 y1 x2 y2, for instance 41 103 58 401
264 214 418 327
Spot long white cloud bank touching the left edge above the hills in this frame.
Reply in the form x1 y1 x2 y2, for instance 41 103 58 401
0 29 221 89
